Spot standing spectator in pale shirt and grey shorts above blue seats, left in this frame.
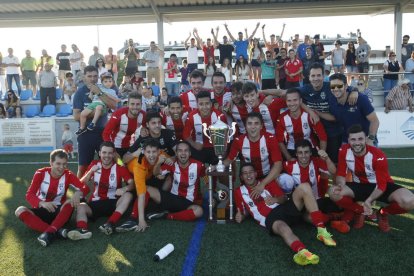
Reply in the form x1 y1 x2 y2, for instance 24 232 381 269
39 63 57 111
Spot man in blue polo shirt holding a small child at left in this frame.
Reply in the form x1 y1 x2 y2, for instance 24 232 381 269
73 66 116 178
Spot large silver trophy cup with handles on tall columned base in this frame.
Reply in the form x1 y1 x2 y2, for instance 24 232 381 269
203 119 236 224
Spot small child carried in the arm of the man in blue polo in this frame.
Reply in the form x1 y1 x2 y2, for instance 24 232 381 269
75 72 119 135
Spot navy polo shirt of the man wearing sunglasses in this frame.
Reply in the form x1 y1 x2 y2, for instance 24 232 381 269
329 94 374 143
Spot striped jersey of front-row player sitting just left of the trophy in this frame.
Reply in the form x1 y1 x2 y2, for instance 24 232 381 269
161 158 205 202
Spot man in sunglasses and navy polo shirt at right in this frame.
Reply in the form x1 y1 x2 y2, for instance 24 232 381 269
329 73 379 145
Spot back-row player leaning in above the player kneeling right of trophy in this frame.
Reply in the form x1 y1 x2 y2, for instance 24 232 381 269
242 82 286 134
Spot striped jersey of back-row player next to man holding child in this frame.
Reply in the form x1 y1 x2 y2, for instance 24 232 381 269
102 107 145 148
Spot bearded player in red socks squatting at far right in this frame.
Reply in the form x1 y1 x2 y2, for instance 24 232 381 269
329 125 414 232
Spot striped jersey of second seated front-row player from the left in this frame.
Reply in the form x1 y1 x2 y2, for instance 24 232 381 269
88 160 132 201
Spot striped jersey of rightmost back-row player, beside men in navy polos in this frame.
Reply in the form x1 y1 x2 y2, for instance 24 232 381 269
276 110 328 150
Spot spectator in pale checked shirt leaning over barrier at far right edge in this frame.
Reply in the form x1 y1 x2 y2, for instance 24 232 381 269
384 79 413 113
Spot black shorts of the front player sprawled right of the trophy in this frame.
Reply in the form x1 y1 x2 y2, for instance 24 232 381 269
265 200 303 233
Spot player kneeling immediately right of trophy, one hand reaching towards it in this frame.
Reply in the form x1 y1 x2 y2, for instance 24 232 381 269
223 112 282 196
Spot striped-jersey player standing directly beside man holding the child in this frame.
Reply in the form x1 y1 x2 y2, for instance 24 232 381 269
102 92 145 158
